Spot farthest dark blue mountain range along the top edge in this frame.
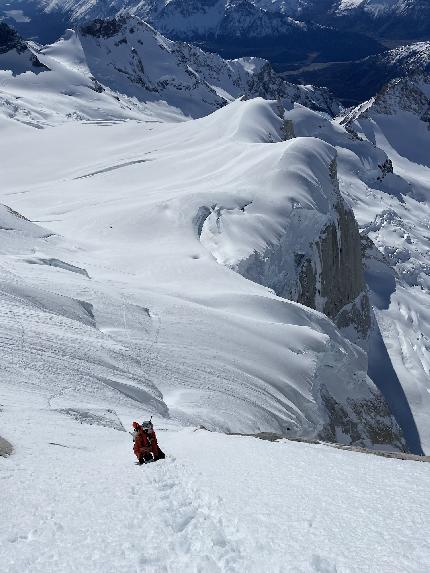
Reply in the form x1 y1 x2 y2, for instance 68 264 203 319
0 0 382 68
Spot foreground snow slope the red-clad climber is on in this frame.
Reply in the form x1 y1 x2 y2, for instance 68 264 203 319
0 381 430 573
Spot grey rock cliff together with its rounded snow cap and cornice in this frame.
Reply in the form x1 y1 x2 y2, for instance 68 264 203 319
200 139 370 346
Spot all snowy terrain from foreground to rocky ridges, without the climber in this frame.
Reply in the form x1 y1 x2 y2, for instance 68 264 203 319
0 3 430 573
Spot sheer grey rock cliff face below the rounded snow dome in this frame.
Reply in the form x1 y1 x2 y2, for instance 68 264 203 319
236 161 370 346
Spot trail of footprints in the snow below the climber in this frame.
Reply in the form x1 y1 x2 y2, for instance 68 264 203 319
131 458 243 572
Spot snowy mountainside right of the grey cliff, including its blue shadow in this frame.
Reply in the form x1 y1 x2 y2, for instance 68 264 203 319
286 76 430 451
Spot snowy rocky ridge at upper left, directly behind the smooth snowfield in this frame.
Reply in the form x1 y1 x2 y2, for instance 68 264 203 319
0 18 339 126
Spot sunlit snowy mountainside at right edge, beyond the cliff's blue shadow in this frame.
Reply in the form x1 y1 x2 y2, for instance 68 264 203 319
343 75 430 448
